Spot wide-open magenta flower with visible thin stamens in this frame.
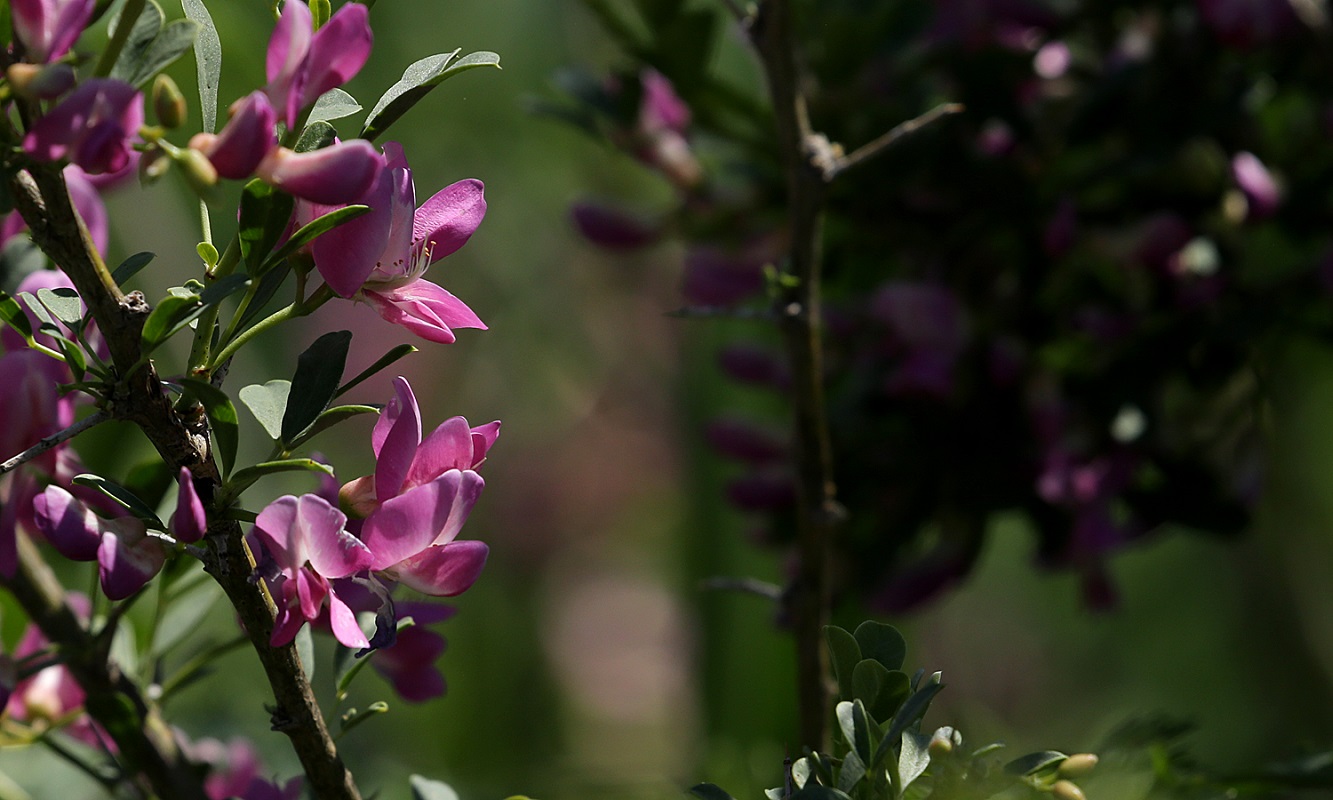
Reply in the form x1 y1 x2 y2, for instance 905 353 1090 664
297 141 487 344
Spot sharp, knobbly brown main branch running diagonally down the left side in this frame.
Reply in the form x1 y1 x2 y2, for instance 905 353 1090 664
9 164 360 800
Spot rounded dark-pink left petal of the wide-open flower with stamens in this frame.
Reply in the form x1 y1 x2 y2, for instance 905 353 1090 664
304 148 395 297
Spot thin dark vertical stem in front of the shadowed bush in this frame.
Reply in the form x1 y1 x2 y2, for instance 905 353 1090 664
749 0 841 749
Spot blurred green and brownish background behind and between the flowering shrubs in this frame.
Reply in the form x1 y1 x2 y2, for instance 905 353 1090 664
0 0 1333 800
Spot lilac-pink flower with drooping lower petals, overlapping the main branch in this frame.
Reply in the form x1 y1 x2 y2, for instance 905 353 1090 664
255 495 372 648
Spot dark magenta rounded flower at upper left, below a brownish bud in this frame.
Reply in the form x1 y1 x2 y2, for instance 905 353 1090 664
23 77 144 175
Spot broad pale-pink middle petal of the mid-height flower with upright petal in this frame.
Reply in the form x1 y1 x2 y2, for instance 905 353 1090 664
361 469 485 569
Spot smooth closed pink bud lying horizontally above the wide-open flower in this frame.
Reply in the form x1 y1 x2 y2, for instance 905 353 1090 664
255 139 384 205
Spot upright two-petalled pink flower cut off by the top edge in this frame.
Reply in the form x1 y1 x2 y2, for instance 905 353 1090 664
265 3 373 128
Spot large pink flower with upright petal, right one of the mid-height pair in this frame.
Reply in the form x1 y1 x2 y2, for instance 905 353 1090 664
343 377 500 597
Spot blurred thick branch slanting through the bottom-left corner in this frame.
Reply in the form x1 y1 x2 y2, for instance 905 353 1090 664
7 535 208 800
